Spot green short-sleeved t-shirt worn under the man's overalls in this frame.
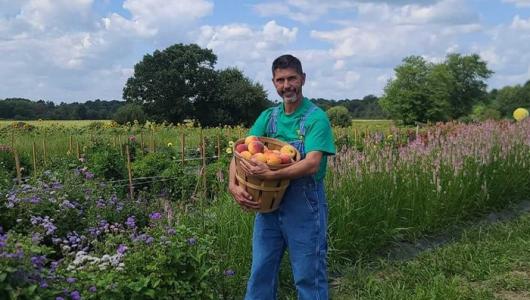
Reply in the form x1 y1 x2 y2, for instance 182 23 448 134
249 97 335 180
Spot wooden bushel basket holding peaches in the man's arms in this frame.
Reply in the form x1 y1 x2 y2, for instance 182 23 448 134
233 137 301 213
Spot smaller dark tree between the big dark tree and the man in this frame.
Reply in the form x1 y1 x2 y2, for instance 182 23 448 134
194 68 272 126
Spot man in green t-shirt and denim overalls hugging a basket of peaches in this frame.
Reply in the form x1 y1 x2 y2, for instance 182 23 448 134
229 55 335 300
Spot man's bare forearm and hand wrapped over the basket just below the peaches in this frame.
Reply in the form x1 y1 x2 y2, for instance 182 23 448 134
234 151 323 179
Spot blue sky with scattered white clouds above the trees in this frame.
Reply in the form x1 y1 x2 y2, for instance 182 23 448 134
0 0 530 103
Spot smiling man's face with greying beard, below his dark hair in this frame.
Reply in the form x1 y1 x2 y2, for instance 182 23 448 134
272 68 305 103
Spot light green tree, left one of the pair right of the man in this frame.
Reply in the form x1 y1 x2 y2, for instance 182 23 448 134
379 56 450 125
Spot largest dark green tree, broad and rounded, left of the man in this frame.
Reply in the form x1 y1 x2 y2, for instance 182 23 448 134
123 44 217 123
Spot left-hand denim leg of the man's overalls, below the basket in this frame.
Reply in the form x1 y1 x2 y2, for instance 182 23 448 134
245 211 285 300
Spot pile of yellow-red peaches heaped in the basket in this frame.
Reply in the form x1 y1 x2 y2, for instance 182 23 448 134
235 135 296 166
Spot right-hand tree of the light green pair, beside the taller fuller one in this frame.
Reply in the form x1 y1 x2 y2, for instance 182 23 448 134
444 54 493 119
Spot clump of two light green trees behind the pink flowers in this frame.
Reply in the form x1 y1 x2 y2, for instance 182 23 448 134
379 54 492 124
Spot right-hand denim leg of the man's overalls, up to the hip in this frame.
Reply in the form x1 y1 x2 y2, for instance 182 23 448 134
279 178 329 300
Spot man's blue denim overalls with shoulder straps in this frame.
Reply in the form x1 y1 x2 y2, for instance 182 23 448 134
245 105 328 300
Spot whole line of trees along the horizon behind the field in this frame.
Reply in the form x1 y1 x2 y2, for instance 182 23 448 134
0 44 530 127
